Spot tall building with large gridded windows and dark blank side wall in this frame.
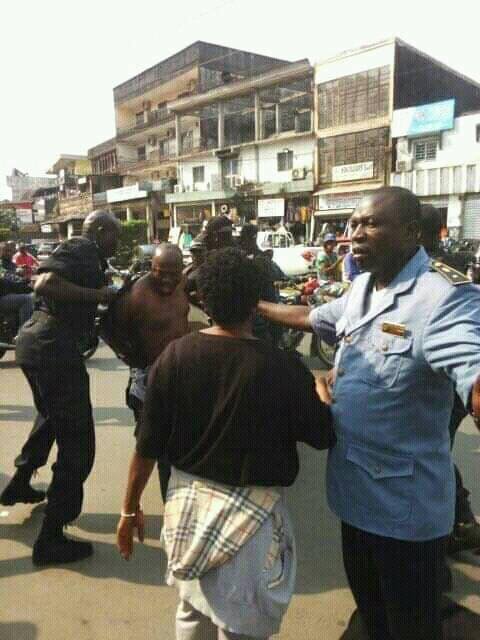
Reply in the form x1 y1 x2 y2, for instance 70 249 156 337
314 38 480 241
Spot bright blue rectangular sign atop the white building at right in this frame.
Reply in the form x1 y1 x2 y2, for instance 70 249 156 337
392 99 455 138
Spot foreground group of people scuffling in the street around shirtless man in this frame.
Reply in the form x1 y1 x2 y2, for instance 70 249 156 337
0 187 480 640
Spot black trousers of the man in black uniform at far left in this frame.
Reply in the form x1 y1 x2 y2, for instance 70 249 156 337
15 358 95 525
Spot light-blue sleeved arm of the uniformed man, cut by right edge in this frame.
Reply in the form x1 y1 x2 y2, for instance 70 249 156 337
423 285 480 426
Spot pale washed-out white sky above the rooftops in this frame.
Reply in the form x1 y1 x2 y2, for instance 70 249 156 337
0 0 480 200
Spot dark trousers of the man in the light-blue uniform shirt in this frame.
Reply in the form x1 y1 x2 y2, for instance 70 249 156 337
342 523 446 640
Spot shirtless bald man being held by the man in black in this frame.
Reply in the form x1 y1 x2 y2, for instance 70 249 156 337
102 243 190 502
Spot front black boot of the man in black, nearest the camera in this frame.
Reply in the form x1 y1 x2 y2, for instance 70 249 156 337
32 518 93 566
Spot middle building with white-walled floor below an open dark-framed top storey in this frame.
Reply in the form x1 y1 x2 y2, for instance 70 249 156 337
166 60 315 235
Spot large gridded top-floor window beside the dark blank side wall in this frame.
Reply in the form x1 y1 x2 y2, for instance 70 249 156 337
318 66 390 129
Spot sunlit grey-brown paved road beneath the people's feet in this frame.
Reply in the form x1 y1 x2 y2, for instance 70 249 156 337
0 347 480 640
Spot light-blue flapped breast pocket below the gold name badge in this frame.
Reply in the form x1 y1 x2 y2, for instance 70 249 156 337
359 330 413 388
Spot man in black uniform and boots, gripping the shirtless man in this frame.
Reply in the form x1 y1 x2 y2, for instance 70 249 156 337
0 211 120 565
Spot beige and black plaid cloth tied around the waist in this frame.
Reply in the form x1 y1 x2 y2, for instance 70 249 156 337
162 468 280 580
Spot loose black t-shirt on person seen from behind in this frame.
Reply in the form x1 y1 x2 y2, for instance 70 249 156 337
137 332 333 486
